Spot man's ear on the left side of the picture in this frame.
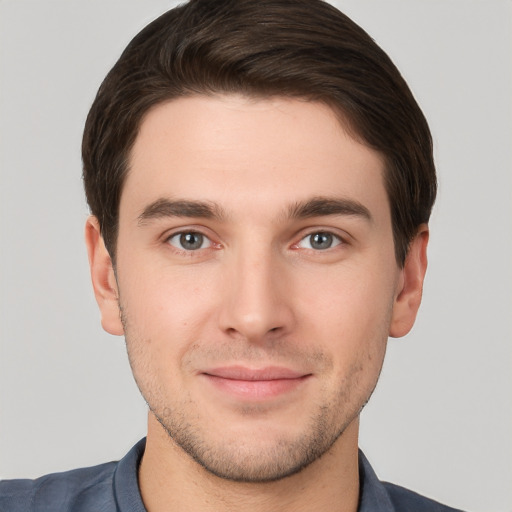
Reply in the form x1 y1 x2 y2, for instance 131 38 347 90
85 215 124 336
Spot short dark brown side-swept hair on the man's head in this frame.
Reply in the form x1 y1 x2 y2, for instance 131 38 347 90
82 0 437 265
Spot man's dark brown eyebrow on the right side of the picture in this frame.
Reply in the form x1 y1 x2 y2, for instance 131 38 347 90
287 197 373 222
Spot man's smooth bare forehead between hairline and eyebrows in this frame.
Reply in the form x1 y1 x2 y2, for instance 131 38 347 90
120 95 387 223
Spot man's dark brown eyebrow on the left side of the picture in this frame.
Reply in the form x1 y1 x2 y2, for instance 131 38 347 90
137 198 225 225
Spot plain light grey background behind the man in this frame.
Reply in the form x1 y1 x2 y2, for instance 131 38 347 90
0 0 512 512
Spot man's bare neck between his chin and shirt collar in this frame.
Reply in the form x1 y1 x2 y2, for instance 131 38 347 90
139 413 359 512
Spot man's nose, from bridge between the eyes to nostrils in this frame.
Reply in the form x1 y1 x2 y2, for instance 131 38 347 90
220 245 294 344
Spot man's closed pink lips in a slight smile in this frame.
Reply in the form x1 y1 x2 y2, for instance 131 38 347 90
201 366 312 401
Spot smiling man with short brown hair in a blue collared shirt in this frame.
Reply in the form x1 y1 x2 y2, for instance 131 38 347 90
0 0 464 512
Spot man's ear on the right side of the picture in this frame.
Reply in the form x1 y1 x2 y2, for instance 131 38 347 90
389 224 429 338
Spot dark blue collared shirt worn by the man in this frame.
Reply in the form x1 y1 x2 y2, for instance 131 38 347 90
0 439 461 512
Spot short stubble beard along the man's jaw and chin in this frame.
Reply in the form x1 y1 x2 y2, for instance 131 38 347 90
122 308 384 483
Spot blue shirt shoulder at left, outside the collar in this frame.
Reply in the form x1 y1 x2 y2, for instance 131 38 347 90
0 462 117 512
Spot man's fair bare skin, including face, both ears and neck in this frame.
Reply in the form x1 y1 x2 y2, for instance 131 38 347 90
86 95 428 512
